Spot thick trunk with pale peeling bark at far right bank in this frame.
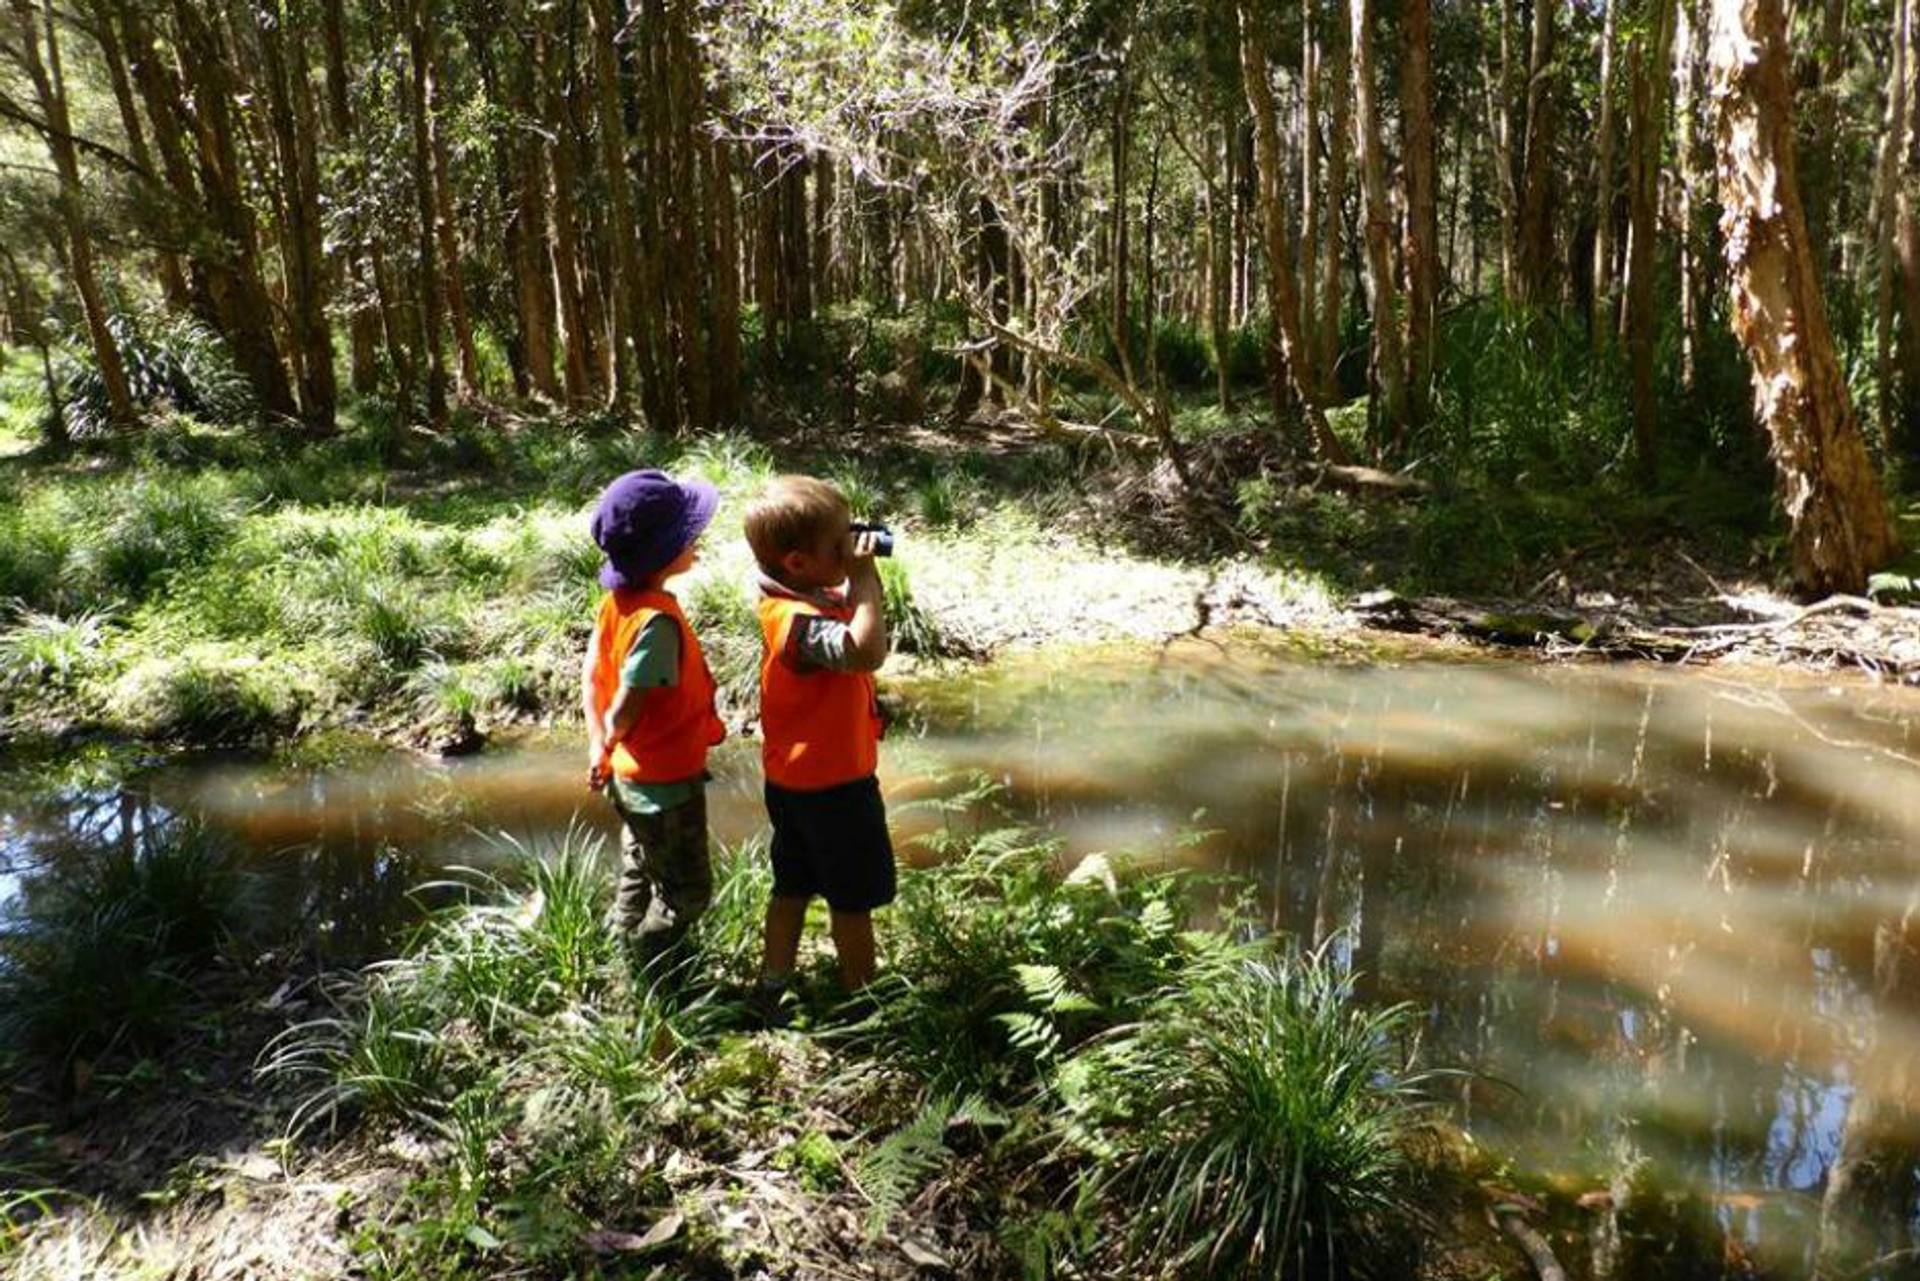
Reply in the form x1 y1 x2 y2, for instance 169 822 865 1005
1709 0 1897 593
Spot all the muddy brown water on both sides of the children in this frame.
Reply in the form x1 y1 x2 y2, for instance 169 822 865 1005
0 643 1920 1275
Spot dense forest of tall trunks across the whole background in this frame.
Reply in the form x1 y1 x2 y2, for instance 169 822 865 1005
0 0 1920 592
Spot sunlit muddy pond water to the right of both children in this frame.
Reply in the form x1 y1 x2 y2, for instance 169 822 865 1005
906 647 1920 1275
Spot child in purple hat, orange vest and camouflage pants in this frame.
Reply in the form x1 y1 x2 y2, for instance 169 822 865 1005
580 471 726 966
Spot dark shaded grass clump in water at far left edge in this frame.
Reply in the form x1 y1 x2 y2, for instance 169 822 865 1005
0 822 261 1072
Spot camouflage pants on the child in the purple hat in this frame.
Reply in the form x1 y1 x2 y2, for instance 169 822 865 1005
614 787 714 964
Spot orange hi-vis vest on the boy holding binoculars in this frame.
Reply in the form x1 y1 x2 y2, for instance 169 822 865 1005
760 595 879 791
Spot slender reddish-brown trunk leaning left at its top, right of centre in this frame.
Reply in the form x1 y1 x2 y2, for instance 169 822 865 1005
1235 0 1350 463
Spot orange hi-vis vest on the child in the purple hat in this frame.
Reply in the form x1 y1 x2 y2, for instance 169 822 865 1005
593 588 726 784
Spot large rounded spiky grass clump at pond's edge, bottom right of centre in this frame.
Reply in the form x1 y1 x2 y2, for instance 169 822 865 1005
1058 935 1425 1277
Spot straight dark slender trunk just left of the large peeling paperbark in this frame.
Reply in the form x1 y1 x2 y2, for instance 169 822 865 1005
1626 0 1674 478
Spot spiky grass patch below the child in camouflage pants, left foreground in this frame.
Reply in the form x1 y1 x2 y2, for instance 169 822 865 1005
259 830 689 1275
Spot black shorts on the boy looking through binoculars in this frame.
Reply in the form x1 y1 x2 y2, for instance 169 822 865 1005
766 776 895 912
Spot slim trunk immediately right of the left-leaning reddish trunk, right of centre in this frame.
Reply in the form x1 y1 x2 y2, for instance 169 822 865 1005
1348 0 1432 453
